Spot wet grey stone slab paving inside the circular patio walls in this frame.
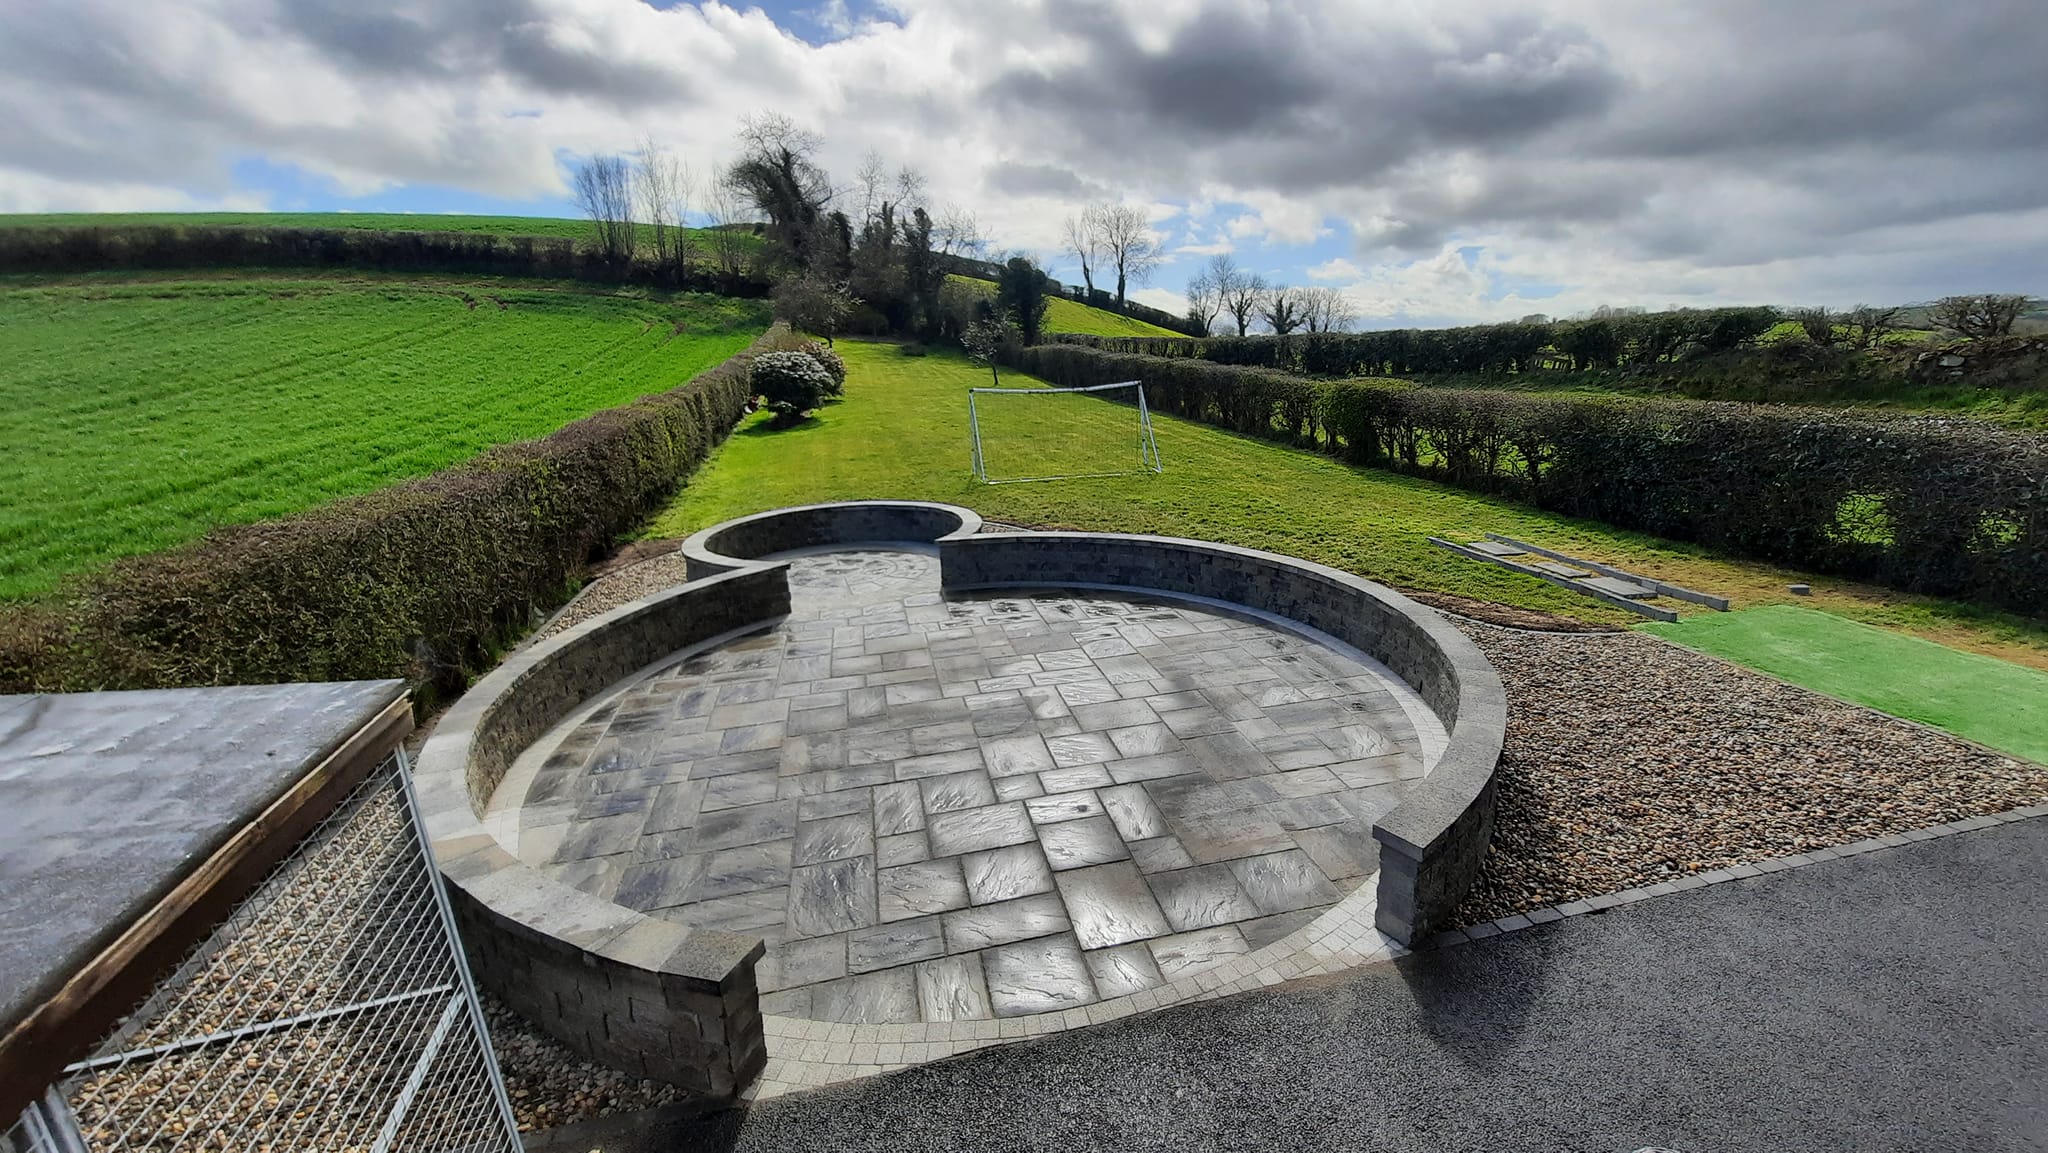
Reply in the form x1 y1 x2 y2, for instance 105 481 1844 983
500 551 1440 1022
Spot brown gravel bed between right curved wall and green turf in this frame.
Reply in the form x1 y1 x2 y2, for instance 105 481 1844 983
1456 621 2048 924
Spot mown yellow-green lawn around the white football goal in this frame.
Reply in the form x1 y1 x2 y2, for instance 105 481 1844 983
647 340 2048 668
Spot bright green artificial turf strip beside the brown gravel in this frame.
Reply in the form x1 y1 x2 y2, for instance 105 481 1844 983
1640 604 2048 764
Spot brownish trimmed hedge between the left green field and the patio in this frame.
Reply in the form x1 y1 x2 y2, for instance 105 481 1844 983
0 326 801 692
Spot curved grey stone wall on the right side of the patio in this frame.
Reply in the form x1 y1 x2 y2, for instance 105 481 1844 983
940 532 1507 944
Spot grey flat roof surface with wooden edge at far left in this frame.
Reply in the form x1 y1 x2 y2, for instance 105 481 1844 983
0 680 406 1036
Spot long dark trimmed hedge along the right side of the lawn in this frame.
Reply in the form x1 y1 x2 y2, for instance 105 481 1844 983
1016 344 2048 616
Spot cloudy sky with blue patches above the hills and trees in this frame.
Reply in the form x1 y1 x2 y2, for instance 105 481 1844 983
0 0 2048 328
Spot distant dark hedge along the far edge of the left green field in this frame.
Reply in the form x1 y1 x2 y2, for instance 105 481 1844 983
0 225 770 297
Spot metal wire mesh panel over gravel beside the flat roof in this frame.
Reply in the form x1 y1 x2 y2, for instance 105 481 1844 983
12 754 520 1153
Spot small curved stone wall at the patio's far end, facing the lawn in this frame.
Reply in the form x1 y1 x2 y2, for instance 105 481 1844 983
678 500 981 580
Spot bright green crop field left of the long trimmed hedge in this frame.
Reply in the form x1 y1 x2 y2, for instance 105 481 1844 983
0 276 766 598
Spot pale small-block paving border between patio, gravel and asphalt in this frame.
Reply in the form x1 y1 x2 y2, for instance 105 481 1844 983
741 805 2048 1102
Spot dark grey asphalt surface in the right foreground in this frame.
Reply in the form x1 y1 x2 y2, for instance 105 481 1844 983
540 819 2048 1153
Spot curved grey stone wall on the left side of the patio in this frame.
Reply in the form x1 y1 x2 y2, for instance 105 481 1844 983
414 565 788 1096
